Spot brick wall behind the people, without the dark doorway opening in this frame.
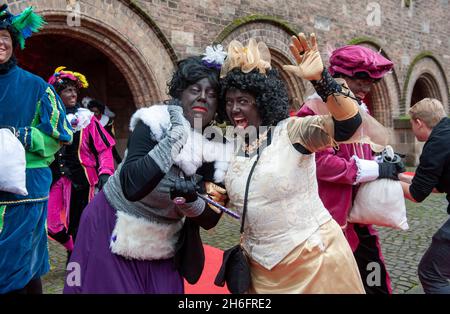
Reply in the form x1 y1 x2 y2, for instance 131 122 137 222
7 0 450 164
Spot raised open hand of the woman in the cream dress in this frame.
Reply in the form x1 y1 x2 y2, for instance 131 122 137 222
283 33 323 81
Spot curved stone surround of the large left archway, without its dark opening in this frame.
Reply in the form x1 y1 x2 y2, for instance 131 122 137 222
10 0 176 150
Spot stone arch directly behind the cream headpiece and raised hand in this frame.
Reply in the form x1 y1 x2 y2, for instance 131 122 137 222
216 17 308 111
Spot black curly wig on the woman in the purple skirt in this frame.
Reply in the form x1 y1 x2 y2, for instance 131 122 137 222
167 56 220 99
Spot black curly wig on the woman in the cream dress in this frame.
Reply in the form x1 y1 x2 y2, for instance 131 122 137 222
217 69 289 126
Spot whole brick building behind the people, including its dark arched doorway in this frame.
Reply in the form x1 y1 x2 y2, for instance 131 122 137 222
8 0 450 163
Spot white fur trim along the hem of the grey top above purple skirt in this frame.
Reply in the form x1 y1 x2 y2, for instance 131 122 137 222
109 211 183 260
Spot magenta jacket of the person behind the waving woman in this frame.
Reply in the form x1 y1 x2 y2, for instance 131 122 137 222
297 99 376 251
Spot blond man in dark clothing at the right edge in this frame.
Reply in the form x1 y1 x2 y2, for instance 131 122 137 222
400 98 450 294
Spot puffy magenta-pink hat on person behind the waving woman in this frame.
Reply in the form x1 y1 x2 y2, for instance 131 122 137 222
328 45 394 79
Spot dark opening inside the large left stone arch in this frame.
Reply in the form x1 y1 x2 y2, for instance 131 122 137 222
16 34 136 156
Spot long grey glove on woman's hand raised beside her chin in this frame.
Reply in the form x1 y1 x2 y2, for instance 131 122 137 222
149 105 190 173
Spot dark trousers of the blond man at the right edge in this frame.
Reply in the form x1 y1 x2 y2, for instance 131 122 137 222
419 219 450 294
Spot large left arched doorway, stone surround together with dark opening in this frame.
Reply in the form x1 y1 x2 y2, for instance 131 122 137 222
10 0 177 152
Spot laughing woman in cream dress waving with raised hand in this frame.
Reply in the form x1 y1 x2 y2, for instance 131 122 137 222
219 34 386 293
